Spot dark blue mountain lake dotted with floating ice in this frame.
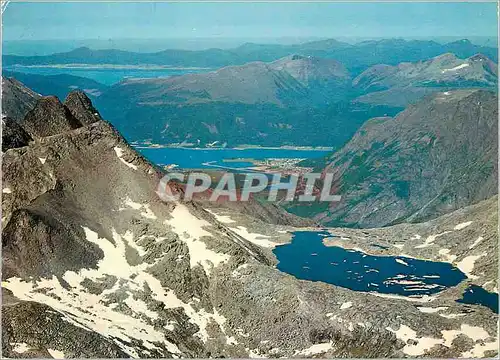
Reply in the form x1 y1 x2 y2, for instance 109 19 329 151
273 231 466 296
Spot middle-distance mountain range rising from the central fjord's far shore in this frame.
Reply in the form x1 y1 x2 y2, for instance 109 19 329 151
95 50 497 147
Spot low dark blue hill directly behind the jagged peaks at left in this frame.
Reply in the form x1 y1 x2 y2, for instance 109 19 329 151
2 70 107 99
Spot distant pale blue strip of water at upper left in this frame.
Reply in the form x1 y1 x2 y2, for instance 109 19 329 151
4 66 209 85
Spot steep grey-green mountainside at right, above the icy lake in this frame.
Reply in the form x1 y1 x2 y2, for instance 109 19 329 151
299 90 498 227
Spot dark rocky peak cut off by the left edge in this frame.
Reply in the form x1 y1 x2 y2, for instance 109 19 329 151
2 76 41 121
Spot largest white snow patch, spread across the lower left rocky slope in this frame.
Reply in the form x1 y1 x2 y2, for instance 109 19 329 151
3 227 184 357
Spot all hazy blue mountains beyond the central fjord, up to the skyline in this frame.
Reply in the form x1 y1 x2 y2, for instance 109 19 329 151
4 40 498 147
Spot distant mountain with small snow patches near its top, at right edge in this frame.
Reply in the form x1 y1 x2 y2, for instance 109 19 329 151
353 53 498 106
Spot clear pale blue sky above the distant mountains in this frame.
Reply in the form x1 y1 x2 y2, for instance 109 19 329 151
3 2 497 41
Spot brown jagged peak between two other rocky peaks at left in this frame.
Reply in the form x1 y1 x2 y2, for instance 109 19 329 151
21 96 82 138
